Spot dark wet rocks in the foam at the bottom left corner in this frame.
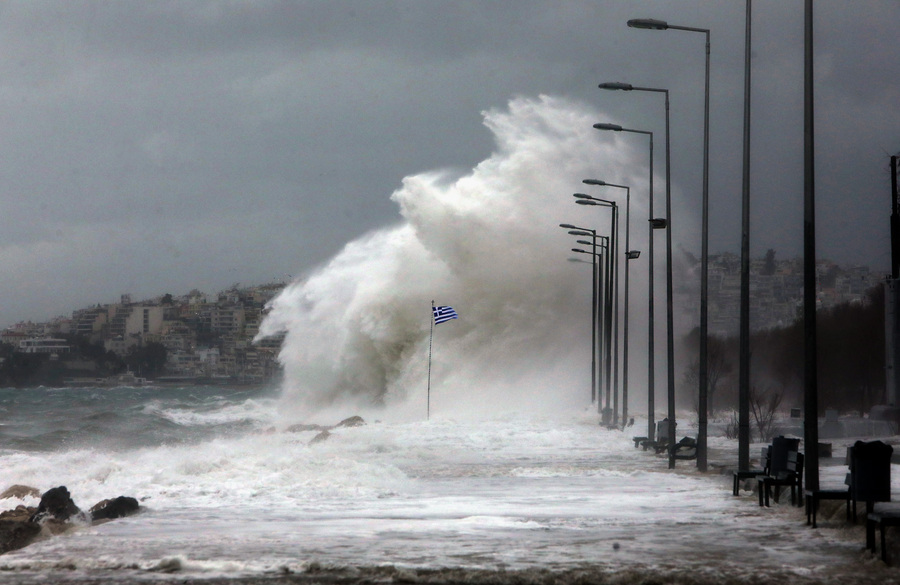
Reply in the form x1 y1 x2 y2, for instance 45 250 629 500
0 485 140 554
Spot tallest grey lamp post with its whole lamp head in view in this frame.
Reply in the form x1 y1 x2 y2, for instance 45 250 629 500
628 18 709 471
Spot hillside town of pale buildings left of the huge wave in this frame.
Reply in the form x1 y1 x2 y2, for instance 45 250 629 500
0 282 285 386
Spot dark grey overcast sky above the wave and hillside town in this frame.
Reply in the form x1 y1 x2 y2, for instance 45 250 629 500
0 0 900 326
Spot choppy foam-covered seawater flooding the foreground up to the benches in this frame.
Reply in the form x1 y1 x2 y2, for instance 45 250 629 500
0 387 900 583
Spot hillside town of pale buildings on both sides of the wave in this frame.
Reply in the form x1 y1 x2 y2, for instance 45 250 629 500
0 250 883 386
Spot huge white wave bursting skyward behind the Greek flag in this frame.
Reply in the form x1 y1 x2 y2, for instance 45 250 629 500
260 96 688 418
